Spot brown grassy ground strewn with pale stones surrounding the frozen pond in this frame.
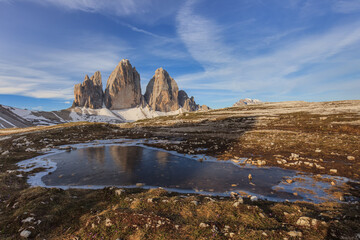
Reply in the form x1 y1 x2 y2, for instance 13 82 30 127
0 101 360 239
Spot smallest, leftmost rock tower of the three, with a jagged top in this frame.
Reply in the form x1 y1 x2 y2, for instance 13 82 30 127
73 71 104 109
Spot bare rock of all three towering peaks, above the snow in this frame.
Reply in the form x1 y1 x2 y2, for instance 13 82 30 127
73 59 207 112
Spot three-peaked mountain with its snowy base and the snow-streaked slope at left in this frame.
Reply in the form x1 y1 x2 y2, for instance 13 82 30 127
0 59 209 128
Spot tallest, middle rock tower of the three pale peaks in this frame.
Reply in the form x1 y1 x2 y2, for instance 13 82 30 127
105 59 141 110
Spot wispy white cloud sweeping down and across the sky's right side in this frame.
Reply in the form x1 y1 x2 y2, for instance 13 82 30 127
176 1 360 100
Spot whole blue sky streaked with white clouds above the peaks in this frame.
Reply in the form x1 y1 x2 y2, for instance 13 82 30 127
0 0 360 110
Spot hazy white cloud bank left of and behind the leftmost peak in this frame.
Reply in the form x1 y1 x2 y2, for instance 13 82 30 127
0 36 131 99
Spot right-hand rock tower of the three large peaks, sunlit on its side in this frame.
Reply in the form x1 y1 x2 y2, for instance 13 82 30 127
144 68 180 112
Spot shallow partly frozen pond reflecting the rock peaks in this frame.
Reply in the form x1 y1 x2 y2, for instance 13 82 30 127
20 140 348 202
